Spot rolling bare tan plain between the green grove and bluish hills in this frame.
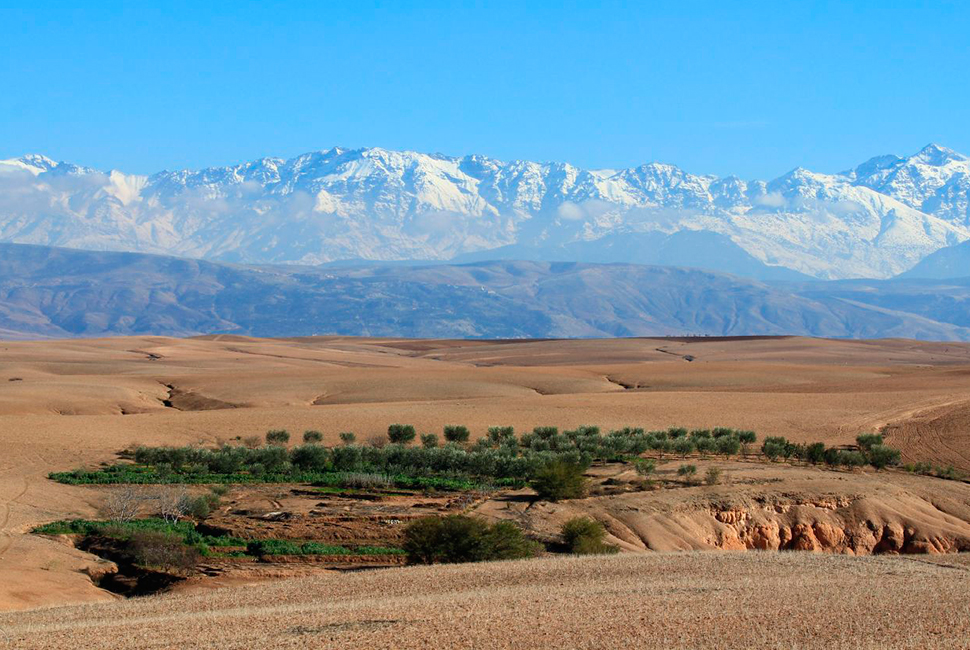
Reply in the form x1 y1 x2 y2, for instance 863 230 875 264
0 337 970 609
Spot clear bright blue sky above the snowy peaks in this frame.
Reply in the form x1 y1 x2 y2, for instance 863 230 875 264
0 0 970 178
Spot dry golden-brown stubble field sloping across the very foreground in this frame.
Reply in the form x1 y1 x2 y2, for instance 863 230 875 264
0 553 970 650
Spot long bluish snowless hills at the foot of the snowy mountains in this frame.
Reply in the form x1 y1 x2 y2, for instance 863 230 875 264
0 244 970 340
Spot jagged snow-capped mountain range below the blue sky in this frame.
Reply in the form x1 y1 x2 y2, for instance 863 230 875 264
0 145 970 279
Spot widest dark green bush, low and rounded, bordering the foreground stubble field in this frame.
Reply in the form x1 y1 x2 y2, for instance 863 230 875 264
404 515 539 564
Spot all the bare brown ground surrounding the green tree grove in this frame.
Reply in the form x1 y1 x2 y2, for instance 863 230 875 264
0 337 970 648
